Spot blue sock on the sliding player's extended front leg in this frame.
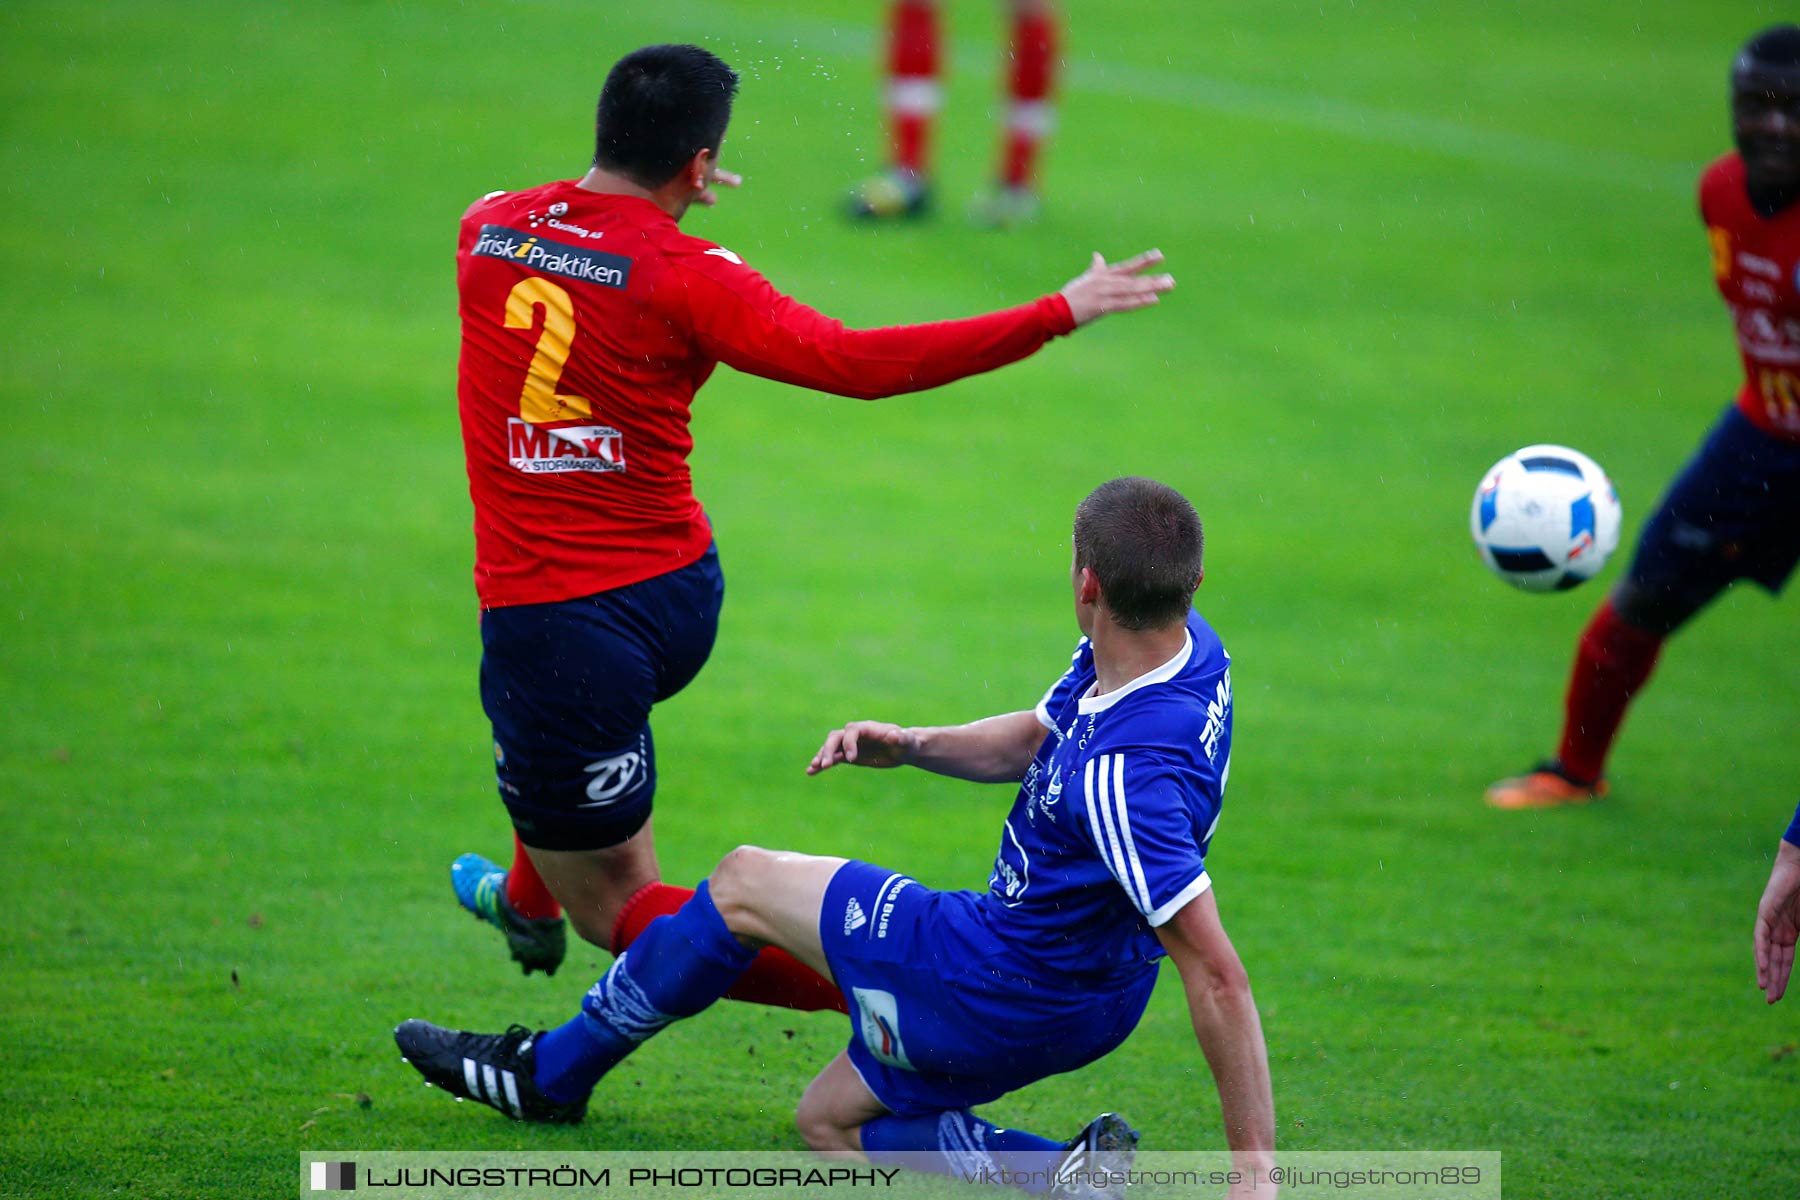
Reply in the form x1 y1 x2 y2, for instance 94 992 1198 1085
535 883 756 1103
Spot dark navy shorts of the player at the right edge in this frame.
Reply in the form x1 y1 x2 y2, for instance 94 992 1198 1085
1629 405 1800 617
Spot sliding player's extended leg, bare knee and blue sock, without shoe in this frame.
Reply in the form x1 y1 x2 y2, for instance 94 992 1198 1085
536 846 844 1103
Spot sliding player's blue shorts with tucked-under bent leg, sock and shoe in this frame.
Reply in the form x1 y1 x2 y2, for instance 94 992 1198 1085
796 862 1156 1191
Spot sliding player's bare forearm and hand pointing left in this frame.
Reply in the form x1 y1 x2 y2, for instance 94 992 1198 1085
806 711 1044 783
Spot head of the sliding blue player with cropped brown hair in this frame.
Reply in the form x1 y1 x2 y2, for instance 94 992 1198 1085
1075 475 1206 630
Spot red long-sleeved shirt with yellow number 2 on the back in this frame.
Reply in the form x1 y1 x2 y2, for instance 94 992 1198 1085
457 182 1075 608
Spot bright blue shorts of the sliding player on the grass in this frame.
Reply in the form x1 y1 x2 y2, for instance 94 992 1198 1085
819 862 1156 1117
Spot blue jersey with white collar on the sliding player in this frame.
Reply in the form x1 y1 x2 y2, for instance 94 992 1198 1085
981 612 1231 975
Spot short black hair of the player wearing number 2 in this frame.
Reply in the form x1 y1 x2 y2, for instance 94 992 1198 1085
594 45 738 187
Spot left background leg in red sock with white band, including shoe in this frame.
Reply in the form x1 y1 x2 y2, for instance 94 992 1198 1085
850 0 943 218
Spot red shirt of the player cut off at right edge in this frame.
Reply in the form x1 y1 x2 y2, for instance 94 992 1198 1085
1699 153 1800 441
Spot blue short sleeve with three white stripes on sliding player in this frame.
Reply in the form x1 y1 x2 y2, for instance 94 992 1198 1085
1082 750 1219 928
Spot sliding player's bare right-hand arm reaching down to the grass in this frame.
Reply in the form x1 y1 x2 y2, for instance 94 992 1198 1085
1156 891 1274 1195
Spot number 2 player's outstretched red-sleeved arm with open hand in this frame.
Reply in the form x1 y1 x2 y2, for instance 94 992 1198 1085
670 250 1175 399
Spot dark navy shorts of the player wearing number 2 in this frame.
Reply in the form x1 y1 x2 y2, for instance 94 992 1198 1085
481 547 725 851
